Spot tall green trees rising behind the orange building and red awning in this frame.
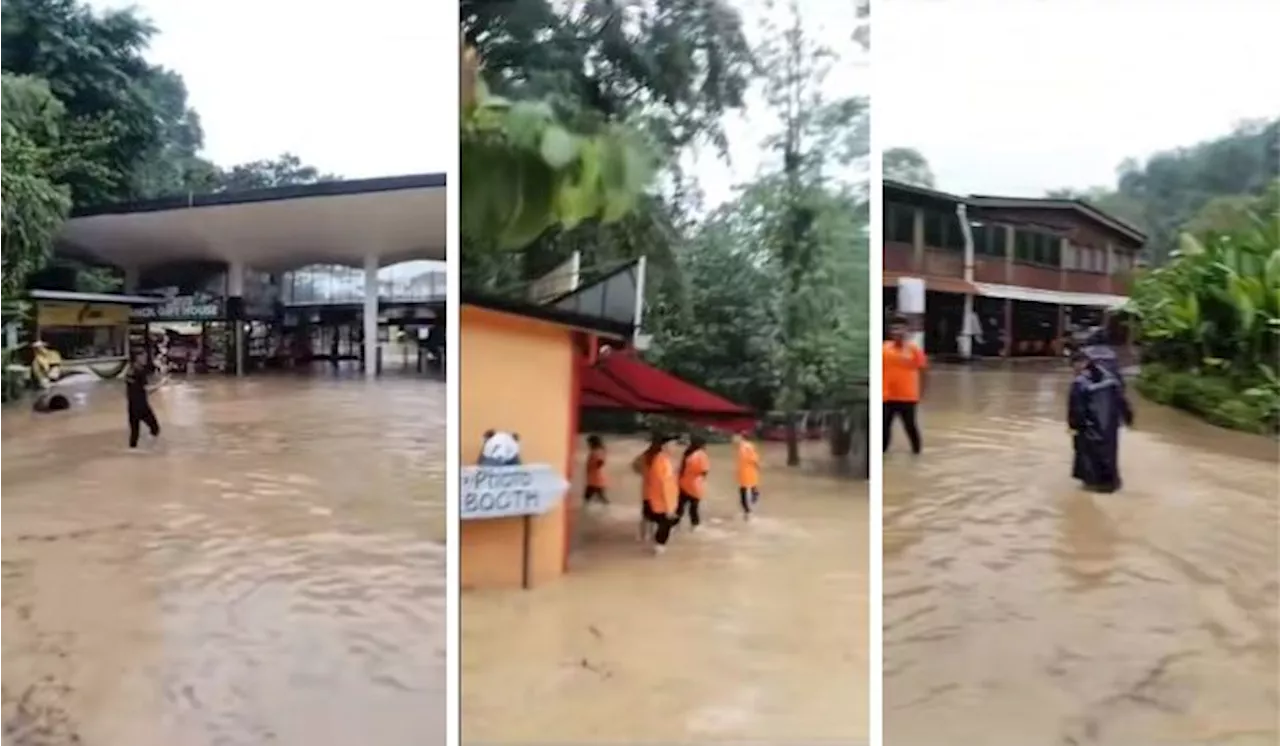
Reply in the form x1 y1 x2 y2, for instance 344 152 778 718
462 0 869 465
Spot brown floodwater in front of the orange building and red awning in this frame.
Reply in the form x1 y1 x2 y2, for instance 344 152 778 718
462 440 868 743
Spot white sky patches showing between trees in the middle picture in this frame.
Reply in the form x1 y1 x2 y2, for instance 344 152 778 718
687 0 876 207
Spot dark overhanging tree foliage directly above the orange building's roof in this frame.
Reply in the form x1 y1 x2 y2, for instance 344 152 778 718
460 0 754 282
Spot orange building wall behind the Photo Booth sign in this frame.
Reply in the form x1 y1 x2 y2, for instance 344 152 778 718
458 306 575 589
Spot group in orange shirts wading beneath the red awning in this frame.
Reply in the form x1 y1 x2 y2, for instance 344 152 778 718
582 433 760 554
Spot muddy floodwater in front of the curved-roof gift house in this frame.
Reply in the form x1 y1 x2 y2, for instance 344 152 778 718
0 377 445 746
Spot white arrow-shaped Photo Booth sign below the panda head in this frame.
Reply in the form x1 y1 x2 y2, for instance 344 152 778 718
460 463 568 521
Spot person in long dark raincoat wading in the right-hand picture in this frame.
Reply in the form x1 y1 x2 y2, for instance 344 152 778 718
1066 351 1133 493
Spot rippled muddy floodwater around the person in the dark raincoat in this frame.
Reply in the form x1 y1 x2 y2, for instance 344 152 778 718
884 370 1280 746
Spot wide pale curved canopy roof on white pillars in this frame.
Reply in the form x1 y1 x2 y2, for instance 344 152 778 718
58 174 447 273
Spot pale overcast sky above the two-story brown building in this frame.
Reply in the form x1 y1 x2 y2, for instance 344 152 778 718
872 0 1280 197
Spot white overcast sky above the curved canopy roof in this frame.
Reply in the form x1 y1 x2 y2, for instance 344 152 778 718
93 0 458 178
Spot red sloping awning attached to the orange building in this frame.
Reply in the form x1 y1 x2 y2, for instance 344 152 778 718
579 352 755 431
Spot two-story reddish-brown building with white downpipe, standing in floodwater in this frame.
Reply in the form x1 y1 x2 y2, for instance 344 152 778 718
883 180 1147 357
